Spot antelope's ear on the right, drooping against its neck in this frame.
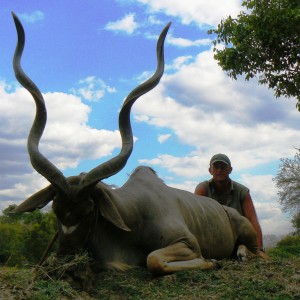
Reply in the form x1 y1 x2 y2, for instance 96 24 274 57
92 185 131 231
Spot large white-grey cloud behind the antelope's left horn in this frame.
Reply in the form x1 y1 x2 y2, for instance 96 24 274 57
0 83 121 203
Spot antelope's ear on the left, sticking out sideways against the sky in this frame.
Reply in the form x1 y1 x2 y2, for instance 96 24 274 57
12 185 56 214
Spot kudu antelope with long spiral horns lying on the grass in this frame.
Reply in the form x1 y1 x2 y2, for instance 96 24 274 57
13 15 257 275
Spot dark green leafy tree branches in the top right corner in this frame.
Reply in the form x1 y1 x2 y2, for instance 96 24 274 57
209 0 300 111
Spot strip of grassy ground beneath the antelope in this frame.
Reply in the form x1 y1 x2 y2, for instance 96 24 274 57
0 255 300 300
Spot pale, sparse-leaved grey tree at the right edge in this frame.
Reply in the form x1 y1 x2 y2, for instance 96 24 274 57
274 150 300 215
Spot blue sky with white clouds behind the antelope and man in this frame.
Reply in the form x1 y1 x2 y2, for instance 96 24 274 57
0 0 300 235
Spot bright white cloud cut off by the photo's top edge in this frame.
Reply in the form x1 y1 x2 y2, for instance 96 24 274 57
137 0 241 26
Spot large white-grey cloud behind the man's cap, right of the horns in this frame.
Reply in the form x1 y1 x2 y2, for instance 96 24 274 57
134 51 300 177
